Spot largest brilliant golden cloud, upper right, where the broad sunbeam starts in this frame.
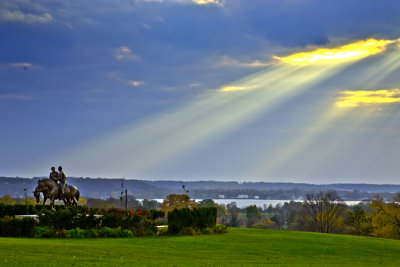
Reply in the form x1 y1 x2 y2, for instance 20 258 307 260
274 39 397 64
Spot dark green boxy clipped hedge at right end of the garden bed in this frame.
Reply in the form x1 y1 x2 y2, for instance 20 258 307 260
168 207 217 234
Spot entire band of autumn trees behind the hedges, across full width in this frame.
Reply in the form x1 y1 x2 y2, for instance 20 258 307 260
0 190 400 239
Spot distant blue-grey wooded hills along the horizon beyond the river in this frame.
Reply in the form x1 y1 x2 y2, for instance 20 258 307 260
0 177 400 200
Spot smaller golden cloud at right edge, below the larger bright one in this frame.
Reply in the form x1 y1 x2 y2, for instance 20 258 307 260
335 88 400 108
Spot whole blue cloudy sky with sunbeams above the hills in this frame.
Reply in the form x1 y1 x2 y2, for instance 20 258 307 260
0 0 400 184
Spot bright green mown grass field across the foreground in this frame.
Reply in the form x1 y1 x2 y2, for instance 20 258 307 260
0 228 400 266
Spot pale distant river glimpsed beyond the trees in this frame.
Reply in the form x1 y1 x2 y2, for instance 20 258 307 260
138 198 360 208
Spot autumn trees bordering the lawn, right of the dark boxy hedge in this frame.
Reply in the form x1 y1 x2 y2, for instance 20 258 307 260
217 190 400 239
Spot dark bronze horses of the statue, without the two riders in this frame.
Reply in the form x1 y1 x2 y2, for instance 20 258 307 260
33 179 79 210
